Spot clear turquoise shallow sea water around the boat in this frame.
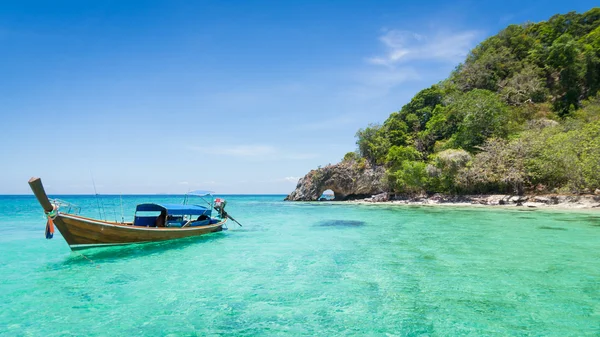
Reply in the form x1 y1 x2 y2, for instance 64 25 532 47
0 196 600 336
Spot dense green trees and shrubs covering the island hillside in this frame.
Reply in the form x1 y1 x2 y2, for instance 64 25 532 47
343 8 600 194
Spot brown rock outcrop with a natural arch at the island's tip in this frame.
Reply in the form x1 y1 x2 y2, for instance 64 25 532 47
285 162 386 201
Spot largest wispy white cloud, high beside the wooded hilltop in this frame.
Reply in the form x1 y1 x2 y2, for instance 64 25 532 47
367 29 480 68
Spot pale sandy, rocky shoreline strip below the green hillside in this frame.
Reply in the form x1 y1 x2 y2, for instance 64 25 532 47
344 193 600 210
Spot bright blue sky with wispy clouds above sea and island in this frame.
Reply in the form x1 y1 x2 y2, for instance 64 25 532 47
0 1 595 194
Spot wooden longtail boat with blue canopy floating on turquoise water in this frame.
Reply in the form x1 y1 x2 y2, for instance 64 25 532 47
29 177 241 250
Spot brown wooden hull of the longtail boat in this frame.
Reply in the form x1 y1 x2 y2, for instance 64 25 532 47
54 213 227 250
